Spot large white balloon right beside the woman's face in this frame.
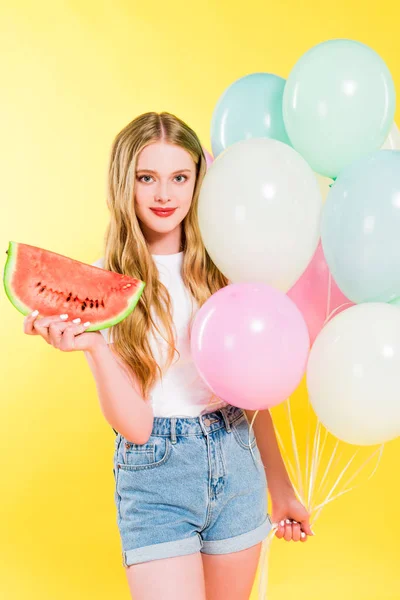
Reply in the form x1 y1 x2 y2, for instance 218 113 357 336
198 138 322 292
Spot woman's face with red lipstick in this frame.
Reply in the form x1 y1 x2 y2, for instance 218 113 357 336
135 141 196 238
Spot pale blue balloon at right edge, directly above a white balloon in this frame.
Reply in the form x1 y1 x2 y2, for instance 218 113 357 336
321 150 400 303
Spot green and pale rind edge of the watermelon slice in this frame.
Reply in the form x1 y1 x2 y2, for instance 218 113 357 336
3 242 146 332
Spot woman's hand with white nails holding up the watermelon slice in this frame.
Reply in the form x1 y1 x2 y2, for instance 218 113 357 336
24 313 107 352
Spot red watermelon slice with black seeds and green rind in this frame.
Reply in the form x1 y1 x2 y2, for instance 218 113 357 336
3 242 145 331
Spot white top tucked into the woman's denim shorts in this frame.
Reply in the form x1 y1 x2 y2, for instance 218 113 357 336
93 252 227 417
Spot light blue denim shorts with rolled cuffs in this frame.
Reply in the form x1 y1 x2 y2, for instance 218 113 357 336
113 404 272 567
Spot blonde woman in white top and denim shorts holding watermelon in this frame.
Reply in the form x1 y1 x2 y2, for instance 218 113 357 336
24 112 312 600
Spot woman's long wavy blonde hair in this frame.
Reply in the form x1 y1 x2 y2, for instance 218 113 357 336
103 112 229 401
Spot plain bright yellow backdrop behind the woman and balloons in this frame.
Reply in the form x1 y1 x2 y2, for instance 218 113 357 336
0 0 400 600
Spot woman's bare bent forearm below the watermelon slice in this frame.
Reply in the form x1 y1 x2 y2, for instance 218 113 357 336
84 338 154 444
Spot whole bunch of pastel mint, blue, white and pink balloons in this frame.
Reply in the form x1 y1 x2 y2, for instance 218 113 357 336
191 39 400 452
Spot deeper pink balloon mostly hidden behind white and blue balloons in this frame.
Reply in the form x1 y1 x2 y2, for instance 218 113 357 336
287 241 353 344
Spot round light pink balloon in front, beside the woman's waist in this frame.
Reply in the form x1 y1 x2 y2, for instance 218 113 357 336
190 282 309 410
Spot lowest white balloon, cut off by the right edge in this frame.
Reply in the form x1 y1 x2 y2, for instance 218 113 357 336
307 302 400 446
